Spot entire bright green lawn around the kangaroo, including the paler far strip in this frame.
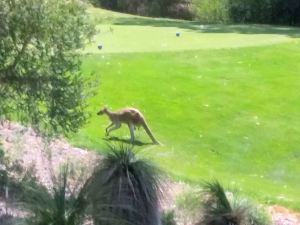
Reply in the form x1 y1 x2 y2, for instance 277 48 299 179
71 9 300 210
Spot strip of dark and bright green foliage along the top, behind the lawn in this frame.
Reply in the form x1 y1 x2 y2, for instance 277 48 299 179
90 0 300 25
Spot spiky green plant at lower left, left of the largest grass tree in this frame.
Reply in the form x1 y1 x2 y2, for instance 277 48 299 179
22 167 87 225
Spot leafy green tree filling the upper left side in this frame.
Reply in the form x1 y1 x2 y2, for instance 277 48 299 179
0 0 93 136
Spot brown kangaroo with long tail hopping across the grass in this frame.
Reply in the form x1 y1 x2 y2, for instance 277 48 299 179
97 107 160 144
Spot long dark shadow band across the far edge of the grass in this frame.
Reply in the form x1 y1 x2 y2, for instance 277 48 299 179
113 17 300 38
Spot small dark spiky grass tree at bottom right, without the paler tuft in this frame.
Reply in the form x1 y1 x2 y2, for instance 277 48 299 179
198 181 247 225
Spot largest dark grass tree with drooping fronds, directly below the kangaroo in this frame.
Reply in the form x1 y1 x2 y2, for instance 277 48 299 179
90 146 161 225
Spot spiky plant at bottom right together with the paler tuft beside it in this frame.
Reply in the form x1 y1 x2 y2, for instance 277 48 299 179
197 181 270 225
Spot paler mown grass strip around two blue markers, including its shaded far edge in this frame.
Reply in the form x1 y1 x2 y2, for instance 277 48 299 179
84 9 300 54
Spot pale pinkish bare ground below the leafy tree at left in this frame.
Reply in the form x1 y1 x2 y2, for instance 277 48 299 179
0 124 98 187
